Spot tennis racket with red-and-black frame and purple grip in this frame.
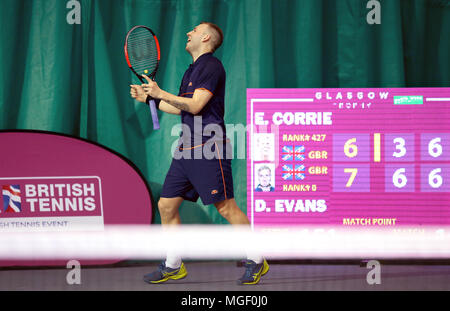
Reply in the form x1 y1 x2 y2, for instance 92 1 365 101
124 26 161 130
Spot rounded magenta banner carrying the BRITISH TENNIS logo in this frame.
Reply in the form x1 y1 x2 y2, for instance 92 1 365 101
0 130 152 265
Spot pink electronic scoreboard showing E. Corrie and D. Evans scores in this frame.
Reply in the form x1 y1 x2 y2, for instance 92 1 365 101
247 88 450 228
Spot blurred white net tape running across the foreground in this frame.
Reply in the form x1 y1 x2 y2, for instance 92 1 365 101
0 225 450 260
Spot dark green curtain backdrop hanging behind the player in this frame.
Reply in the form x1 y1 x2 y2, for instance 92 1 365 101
0 0 450 223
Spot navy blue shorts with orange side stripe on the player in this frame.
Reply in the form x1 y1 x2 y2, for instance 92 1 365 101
161 143 234 205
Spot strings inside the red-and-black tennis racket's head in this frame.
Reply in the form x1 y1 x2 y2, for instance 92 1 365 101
127 28 158 75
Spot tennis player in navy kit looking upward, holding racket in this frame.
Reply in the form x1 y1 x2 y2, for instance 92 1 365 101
130 22 269 284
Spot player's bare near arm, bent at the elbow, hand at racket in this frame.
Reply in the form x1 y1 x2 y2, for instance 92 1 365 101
142 75 213 115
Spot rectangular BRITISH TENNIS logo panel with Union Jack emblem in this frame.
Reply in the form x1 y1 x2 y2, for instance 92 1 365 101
0 176 104 230
